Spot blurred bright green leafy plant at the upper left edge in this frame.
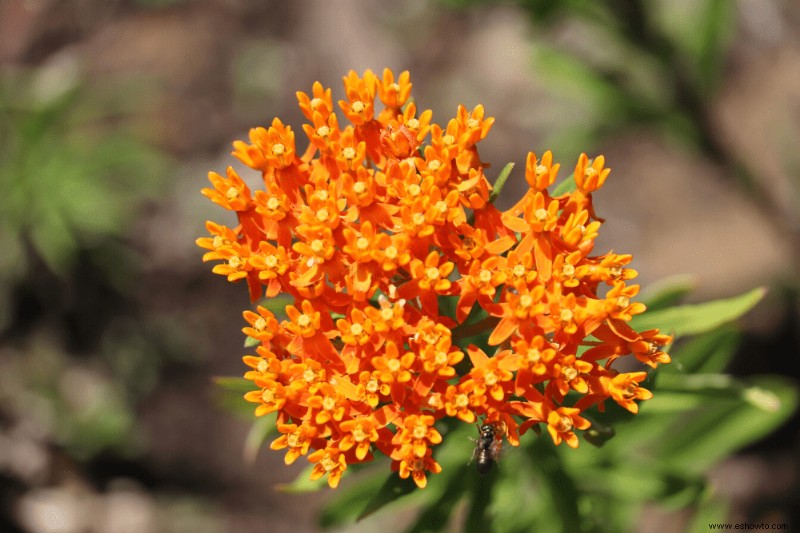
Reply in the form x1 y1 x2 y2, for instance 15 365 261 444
0 65 166 279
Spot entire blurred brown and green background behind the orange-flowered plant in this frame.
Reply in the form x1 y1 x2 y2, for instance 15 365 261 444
0 0 800 533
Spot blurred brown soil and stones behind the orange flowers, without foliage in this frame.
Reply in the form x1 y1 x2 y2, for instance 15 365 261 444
0 0 800 533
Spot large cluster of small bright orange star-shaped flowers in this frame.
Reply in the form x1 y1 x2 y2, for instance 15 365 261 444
198 69 670 487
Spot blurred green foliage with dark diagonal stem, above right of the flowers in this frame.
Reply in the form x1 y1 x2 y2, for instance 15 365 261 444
442 0 736 163
